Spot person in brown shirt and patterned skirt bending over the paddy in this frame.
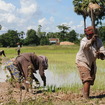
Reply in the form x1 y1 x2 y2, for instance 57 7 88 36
6 53 48 91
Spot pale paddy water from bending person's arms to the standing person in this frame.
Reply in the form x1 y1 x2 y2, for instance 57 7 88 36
35 70 81 87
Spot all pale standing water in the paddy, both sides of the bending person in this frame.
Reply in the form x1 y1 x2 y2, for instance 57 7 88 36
0 65 81 87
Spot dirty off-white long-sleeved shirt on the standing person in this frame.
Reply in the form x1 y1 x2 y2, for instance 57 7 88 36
76 37 105 70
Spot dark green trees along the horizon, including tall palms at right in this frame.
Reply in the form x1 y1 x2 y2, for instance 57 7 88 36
0 0 105 47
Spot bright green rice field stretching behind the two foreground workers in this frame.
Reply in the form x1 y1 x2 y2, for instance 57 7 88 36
0 45 105 90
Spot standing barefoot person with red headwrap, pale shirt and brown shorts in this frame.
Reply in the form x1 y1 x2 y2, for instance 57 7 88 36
76 26 105 98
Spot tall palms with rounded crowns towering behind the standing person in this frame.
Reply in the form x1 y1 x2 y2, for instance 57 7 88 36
73 0 105 31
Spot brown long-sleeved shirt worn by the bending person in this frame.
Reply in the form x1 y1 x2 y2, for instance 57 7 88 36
14 53 48 77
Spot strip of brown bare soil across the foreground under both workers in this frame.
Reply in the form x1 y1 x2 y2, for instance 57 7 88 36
0 82 105 105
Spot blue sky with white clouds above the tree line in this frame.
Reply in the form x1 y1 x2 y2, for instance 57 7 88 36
0 0 99 34
